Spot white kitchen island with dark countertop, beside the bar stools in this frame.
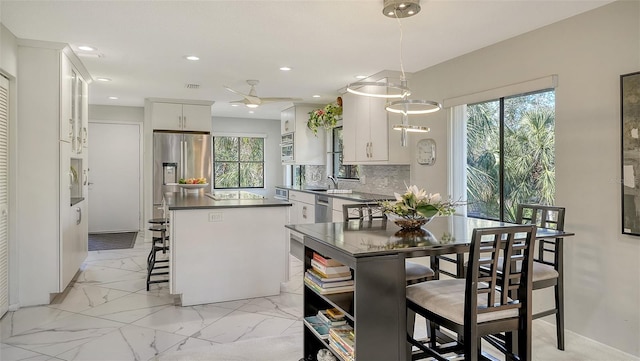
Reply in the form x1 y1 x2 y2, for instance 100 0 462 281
164 191 291 306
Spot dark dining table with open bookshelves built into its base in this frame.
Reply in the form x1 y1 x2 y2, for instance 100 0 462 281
286 215 574 361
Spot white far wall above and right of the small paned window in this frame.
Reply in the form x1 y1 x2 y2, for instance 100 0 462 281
212 117 282 197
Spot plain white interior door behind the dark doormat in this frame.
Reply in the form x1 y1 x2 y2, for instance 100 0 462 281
88 122 142 233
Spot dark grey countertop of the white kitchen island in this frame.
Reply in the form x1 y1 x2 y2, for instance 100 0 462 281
165 191 291 211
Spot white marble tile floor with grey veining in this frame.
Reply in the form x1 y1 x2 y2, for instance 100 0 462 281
0 236 638 361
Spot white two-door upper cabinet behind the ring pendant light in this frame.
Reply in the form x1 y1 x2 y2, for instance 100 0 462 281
342 88 410 164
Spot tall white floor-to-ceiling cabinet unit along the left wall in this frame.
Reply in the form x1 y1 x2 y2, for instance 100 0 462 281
16 40 91 306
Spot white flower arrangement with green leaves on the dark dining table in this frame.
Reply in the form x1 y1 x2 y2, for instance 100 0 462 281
379 185 459 220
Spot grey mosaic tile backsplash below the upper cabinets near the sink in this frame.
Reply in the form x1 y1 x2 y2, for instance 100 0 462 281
304 165 411 195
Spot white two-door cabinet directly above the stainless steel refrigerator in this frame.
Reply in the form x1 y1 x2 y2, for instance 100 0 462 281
151 101 213 132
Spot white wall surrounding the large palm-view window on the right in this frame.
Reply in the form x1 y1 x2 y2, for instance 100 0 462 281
410 1 640 356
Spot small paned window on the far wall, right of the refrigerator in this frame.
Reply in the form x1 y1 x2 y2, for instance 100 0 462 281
213 136 264 189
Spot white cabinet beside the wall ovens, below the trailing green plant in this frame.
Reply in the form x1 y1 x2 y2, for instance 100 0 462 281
280 104 327 165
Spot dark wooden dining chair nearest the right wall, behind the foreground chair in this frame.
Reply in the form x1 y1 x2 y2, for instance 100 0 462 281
516 204 565 350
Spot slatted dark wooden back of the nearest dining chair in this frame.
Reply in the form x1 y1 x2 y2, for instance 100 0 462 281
465 225 536 322
